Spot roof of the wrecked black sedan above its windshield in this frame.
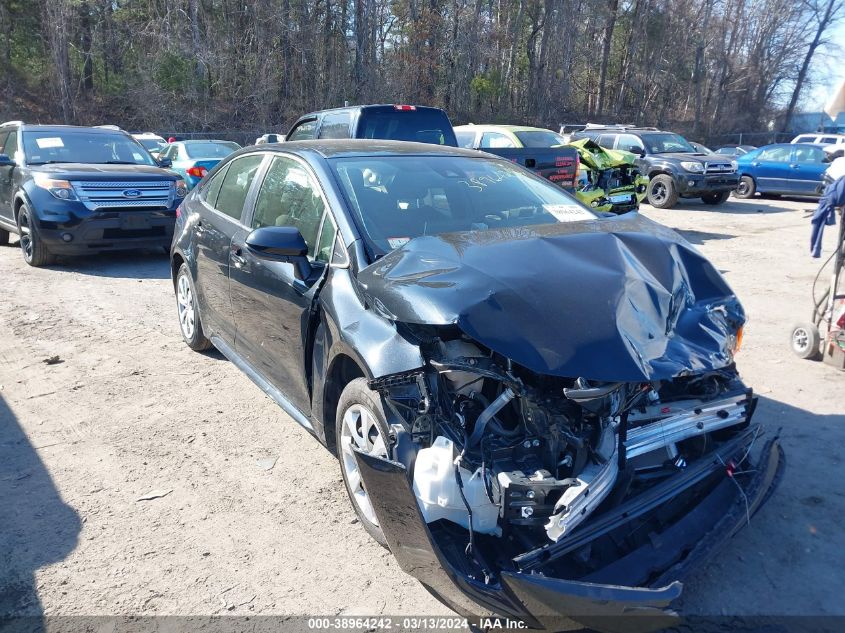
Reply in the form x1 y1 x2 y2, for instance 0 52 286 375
252 139 482 158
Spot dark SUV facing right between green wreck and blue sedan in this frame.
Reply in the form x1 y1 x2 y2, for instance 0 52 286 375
573 125 739 209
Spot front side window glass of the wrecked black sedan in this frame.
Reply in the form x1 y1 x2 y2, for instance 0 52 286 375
252 156 331 257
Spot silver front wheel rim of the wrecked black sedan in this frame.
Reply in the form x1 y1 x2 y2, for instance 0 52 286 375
340 404 387 526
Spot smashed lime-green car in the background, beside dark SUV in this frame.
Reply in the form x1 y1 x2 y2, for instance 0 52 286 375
569 138 648 213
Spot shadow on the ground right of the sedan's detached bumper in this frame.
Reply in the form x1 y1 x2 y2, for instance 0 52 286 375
674 396 845 616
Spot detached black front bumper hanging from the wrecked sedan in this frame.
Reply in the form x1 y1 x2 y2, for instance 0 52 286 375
356 431 785 633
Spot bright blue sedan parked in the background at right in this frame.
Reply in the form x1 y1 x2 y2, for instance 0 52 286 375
734 143 829 198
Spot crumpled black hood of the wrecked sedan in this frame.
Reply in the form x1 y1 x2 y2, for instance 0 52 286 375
358 213 745 382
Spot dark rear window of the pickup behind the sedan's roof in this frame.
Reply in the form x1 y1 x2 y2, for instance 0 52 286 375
355 108 458 147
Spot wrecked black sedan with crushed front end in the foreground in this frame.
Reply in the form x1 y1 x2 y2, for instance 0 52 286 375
172 141 784 630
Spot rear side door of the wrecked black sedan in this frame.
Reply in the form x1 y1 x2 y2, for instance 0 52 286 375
194 154 264 345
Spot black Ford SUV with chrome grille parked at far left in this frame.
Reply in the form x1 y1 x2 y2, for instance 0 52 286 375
0 121 188 266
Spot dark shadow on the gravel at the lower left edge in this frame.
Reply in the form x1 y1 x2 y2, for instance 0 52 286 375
0 397 81 631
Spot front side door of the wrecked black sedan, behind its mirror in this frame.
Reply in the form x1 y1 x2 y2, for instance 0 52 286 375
231 154 337 414
